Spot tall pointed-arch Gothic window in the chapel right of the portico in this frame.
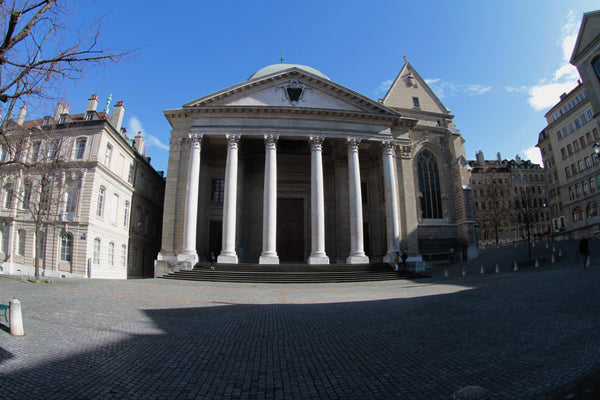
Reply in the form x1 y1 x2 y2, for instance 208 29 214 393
417 150 443 218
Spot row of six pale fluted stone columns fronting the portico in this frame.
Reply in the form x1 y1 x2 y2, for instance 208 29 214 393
182 133 400 264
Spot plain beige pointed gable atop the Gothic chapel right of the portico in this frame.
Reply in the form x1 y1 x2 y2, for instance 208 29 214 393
383 62 450 114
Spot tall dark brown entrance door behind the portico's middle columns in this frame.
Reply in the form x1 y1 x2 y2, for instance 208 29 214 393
277 197 304 262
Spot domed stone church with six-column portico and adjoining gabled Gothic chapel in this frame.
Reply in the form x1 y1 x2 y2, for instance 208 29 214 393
156 62 477 276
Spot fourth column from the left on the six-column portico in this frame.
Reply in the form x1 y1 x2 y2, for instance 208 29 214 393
308 136 329 264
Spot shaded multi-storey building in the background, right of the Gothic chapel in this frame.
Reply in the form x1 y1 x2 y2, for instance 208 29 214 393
469 151 551 248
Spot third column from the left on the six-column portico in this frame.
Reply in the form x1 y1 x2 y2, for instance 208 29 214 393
258 135 279 264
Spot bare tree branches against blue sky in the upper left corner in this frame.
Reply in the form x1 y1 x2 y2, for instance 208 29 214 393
0 0 129 133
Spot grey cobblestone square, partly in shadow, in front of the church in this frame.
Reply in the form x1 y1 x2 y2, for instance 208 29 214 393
0 242 600 400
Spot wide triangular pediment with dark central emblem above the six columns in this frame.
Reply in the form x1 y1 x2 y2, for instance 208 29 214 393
183 68 398 115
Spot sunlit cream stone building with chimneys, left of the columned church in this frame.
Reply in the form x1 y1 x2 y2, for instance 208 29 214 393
0 95 165 279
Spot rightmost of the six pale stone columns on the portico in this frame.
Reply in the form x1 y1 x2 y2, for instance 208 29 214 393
383 140 400 262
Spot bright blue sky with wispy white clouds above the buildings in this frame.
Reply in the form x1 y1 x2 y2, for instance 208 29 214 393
29 0 598 175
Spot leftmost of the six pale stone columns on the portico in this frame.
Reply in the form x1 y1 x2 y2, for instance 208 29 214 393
182 133 202 267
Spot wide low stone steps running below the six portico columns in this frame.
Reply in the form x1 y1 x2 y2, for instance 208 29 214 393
163 263 428 283
